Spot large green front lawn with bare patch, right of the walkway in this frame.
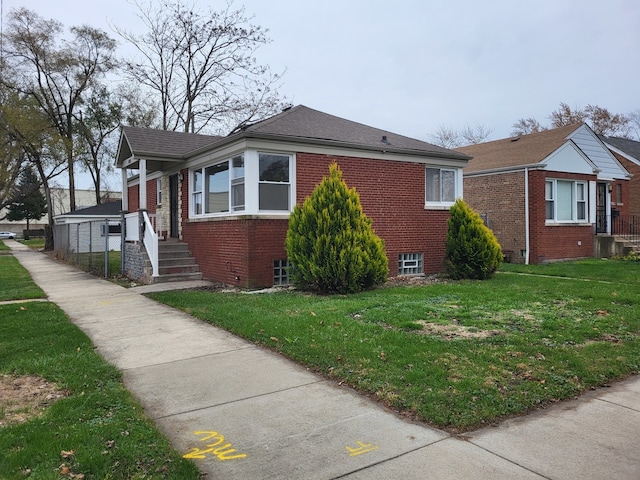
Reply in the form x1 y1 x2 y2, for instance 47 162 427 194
150 261 640 431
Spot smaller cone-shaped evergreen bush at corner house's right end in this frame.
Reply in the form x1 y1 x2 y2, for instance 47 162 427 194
445 199 502 280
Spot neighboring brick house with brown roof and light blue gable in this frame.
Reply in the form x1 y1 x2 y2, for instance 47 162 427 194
458 123 629 263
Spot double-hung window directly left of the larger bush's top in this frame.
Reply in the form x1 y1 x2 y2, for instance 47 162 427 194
258 153 291 210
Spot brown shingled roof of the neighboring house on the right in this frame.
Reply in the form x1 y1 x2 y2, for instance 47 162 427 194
456 123 583 173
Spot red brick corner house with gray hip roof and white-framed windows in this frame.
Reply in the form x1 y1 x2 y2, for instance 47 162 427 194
117 106 469 287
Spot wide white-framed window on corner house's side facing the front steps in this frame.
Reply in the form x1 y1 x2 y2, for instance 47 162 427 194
191 155 244 215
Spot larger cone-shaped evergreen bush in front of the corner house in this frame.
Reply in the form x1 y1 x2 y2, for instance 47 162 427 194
286 162 389 293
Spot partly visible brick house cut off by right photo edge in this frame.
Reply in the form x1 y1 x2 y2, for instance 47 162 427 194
599 135 640 218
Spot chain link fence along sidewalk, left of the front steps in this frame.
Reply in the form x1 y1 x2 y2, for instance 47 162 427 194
53 219 122 278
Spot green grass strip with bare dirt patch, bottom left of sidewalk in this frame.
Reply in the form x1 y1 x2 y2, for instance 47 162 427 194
0 302 199 479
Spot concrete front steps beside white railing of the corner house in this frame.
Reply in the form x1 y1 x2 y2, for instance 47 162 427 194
145 239 202 283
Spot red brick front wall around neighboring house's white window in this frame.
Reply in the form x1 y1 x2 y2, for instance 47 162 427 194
529 170 596 263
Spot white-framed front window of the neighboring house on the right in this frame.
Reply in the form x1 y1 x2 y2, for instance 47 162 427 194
544 179 588 223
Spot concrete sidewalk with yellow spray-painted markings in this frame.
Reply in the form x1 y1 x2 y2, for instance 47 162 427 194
6 241 640 480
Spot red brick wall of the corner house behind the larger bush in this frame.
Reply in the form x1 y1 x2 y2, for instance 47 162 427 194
181 153 449 287
